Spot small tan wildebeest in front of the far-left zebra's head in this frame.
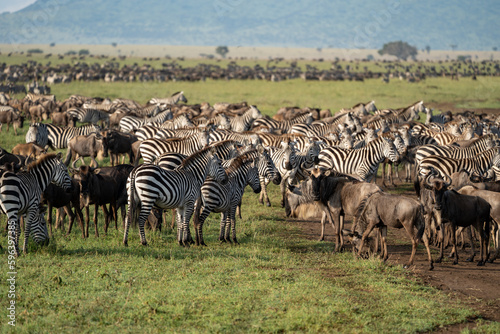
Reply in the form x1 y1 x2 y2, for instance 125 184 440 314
64 133 108 167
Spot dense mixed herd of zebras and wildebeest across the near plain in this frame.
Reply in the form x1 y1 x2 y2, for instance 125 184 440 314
0 92 500 269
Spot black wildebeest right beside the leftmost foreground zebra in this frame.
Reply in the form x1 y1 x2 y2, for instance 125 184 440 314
41 179 85 238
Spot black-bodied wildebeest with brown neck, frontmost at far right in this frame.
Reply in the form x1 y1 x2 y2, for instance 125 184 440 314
417 172 491 266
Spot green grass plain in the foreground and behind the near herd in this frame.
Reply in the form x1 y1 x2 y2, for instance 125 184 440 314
0 58 500 333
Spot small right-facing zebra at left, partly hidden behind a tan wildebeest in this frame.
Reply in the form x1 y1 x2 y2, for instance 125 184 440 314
26 123 101 150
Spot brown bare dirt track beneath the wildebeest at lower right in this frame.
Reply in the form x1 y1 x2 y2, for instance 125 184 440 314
288 179 500 333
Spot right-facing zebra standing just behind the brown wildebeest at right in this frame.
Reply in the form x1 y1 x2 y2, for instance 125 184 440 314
318 137 399 182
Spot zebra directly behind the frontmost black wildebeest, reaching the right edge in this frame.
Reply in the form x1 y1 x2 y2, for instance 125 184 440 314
418 146 500 177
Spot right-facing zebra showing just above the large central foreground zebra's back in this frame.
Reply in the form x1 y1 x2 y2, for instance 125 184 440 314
139 132 209 163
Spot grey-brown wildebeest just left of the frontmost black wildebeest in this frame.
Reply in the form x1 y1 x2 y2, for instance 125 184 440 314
353 192 434 270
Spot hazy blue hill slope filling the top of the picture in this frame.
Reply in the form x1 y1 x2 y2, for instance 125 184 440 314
0 0 500 51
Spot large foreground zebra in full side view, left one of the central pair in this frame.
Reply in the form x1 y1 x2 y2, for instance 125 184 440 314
123 147 228 246
